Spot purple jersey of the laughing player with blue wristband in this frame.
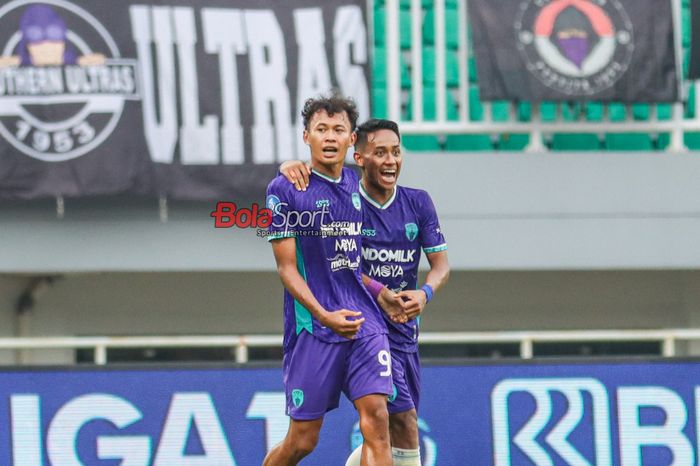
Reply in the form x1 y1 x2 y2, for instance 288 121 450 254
359 186 447 352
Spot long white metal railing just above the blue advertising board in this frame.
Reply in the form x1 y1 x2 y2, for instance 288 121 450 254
0 328 700 365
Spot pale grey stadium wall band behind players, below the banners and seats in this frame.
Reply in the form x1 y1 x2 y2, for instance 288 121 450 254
0 153 700 273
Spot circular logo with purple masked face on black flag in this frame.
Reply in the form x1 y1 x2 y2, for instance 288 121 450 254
514 0 634 96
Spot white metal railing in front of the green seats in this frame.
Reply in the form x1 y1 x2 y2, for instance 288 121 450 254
384 0 700 152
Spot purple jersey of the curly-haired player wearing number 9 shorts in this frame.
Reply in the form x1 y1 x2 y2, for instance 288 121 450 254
267 168 387 348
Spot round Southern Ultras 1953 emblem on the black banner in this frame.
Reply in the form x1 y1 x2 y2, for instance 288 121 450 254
0 0 139 162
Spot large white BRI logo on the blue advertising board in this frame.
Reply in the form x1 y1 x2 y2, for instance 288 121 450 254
491 378 700 466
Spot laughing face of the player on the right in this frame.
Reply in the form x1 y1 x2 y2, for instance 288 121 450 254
355 129 402 190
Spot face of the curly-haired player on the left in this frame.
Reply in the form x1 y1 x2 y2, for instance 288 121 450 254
304 110 355 167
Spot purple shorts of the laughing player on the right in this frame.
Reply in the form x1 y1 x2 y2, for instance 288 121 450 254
388 350 420 414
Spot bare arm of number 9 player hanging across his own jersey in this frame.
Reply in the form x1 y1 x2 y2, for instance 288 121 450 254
271 238 365 338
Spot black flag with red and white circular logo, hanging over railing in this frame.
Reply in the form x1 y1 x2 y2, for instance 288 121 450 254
469 0 678 102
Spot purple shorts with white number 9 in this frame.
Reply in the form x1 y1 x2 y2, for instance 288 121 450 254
283 331 392 420
